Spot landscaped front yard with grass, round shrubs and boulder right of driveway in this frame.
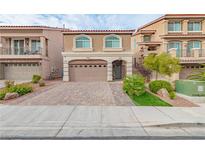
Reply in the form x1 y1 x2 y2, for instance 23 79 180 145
123 74 198 107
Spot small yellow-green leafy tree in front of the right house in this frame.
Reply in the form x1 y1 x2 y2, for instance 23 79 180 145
144 53 181 80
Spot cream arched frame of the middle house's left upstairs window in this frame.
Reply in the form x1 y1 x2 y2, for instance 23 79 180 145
73 34 93 51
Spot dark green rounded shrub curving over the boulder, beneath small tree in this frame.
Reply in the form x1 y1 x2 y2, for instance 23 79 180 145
149 80 176 99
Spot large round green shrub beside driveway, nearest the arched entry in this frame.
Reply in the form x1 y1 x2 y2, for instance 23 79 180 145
123 74 145 96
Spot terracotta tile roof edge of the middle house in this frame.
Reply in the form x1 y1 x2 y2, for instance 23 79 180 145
62 29 135 34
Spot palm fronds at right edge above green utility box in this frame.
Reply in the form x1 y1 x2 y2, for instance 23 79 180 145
187 64 205 81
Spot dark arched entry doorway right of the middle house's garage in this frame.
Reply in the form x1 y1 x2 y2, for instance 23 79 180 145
112 60 126 80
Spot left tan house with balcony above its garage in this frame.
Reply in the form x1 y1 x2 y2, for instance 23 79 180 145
0 26 63 80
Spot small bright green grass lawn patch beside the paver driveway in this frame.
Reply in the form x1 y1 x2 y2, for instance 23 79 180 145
130 92 171 106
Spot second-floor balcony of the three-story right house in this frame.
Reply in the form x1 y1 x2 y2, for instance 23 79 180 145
168 48 205 63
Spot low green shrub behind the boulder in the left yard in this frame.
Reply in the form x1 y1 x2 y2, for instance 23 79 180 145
8 83 33 96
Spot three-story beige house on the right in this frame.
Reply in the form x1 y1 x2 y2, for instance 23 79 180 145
133 14 205 79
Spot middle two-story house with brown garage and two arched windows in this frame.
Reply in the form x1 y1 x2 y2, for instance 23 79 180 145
62 30 134 81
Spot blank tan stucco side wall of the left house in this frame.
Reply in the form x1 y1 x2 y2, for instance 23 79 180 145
43 30 63 77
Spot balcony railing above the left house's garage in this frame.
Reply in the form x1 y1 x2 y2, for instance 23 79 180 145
0 47 42 55
